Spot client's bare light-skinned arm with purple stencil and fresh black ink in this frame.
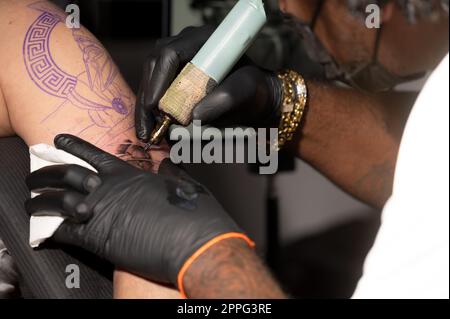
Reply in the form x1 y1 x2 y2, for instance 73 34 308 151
0 0 180 298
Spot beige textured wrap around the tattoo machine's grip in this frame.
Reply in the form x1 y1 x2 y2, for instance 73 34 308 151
159 63 217 126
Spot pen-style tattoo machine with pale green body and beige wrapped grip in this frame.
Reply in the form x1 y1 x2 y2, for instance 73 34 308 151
150 0 267 145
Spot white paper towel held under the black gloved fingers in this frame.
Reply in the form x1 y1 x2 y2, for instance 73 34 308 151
30 144 96 248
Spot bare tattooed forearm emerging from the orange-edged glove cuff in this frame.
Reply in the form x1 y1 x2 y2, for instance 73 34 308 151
184 239 286 299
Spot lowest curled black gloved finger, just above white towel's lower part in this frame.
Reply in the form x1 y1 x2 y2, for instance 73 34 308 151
25 191 92 223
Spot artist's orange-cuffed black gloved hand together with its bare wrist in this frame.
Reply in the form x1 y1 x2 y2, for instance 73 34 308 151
25 135 284 298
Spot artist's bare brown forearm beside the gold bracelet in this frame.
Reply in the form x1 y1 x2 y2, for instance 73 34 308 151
290 83 416 208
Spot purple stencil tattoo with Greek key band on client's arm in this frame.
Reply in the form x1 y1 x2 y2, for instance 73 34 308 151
23 1 133 144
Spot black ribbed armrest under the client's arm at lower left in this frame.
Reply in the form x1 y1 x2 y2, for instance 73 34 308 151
0 138 113 299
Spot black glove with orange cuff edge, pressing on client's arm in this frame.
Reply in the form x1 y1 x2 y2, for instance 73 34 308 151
25 135 251 285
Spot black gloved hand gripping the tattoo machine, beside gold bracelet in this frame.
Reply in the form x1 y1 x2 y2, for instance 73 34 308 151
136 26 283 142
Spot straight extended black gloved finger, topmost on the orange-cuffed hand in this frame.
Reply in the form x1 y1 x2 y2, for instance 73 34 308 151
55 134 125 173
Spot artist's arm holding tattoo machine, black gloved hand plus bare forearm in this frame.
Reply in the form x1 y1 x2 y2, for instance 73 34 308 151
137 27 415 207
